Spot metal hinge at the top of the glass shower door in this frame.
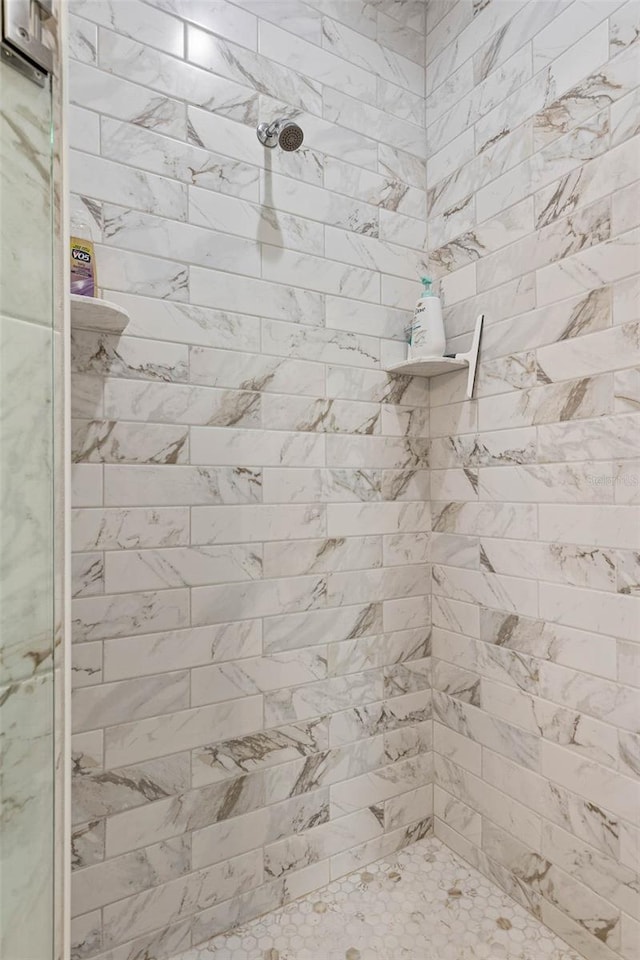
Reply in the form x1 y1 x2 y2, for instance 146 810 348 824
2 0 53 86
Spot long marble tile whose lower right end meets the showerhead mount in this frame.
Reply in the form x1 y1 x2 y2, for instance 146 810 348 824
99 29 258 123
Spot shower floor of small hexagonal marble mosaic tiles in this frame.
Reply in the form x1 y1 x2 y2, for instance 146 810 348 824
175 838 582 960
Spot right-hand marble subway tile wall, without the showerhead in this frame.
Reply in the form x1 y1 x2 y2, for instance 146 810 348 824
426 0 640 960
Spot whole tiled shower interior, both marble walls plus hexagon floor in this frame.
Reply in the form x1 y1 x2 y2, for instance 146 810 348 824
0 0 640 960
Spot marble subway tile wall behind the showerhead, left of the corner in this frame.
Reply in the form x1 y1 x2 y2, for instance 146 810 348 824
70 0 433 960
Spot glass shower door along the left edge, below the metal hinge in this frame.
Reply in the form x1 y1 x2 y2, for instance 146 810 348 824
0 24 60 960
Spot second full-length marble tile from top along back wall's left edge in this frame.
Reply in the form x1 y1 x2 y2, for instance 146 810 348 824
69 59 187 138
